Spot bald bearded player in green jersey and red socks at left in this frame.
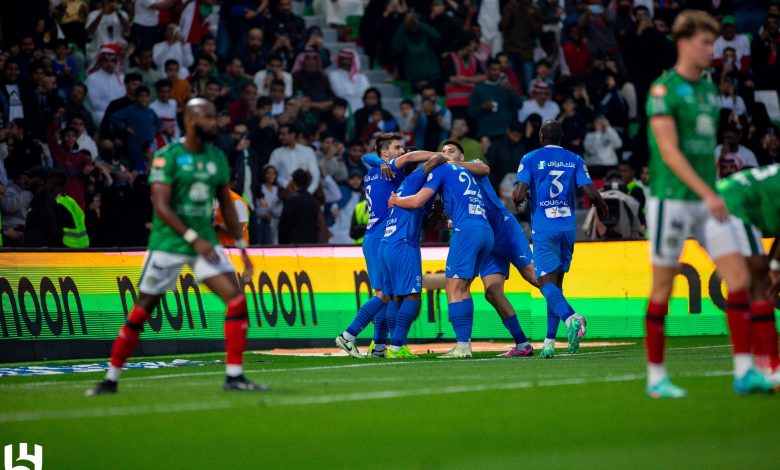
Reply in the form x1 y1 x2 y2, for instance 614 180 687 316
87 98 268 396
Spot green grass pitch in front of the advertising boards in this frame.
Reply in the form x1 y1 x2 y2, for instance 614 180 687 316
0 337 780 469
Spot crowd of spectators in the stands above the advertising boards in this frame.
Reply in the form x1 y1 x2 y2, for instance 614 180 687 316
0 0 780 247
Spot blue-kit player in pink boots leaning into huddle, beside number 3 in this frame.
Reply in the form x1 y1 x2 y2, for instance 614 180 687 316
442 141 539 357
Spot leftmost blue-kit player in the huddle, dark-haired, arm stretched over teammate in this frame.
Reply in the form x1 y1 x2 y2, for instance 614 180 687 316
336 132 433 358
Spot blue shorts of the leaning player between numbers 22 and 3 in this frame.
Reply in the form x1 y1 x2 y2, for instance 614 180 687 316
479 220 534 279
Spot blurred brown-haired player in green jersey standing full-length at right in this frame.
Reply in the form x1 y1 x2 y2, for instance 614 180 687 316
645 10 771 398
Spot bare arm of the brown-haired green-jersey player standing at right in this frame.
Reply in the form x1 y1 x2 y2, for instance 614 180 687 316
650 116 729 222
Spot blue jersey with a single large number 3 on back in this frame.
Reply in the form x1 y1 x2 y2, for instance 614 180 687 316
516 145 593 233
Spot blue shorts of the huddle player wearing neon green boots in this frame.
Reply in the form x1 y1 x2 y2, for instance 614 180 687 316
382 240 422 297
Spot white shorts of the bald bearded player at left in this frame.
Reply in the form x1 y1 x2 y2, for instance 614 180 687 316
138 245 236 295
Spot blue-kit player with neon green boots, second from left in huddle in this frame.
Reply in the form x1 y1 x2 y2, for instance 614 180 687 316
381 164 442 359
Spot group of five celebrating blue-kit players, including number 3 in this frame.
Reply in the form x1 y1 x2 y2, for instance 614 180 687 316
336 121 607 359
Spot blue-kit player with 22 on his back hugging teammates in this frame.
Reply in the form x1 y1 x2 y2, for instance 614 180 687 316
389 157 493 359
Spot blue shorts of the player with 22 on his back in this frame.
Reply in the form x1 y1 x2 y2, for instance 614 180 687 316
445 226 493 279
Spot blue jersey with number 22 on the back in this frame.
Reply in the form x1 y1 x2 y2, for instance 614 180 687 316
423 164 490 231
